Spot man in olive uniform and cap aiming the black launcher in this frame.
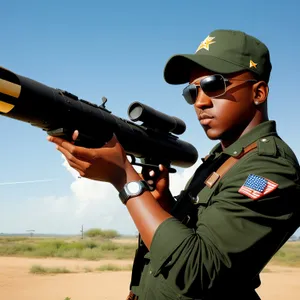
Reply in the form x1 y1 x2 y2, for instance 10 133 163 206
49 30 300 300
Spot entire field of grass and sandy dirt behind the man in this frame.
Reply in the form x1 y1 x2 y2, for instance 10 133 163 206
0 237 300 300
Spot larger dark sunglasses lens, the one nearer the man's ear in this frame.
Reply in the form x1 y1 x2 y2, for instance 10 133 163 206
201 74 226 98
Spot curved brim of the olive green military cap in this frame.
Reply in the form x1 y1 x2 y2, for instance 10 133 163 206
164 54 245 84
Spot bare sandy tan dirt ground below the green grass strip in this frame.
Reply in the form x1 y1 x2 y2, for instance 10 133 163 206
0 257 300 300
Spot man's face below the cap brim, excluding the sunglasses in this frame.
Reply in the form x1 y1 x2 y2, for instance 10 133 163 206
190 70 256 141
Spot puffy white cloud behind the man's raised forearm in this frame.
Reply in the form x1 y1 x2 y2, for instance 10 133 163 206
45 156 196 234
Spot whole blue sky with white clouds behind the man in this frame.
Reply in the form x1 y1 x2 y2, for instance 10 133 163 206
0 0 300 234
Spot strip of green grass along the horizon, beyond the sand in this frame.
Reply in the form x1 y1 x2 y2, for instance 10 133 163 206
0 234 300 272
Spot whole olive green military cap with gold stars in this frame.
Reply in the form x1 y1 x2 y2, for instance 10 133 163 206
164 29 272 84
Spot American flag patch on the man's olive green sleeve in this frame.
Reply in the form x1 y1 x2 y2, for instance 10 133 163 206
239 174 278 200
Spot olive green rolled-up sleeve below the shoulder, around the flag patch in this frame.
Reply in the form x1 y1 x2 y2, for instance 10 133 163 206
150 154 300 295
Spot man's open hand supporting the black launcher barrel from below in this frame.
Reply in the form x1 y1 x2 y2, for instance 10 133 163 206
48 130 130 189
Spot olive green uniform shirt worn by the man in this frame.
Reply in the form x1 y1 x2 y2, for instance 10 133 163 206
131 121 300 300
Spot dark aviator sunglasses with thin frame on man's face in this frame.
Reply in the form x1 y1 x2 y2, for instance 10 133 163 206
182 74 257 104
